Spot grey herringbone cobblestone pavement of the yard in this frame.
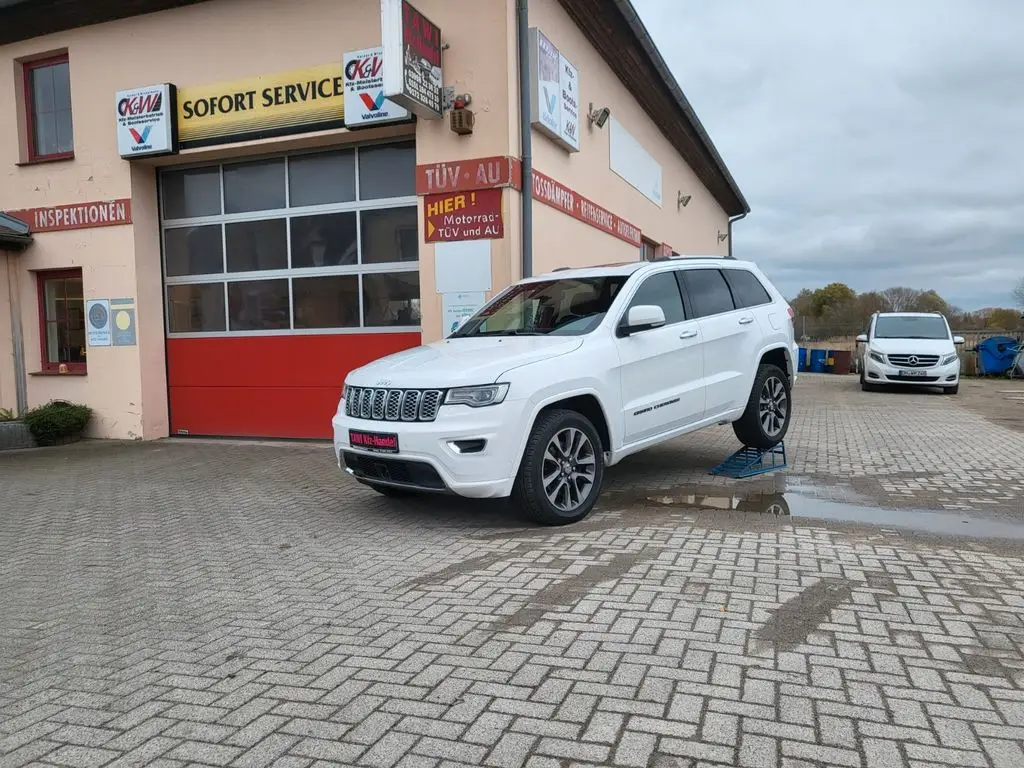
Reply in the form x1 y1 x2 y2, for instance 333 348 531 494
0 377 1024 768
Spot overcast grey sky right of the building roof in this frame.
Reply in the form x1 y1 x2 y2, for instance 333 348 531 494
633 0 1024 309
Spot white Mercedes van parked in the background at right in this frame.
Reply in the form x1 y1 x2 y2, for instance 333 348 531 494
857 312 964 394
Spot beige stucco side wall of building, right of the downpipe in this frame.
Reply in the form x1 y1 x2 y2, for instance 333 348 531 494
529 0 728 263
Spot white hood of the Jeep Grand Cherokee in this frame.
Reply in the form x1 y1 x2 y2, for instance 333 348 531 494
346 336 583 389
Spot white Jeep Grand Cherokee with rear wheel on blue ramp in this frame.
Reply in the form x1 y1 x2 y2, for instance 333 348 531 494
333 257 797 524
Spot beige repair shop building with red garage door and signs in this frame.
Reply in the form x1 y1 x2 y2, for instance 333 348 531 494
0 0 749 439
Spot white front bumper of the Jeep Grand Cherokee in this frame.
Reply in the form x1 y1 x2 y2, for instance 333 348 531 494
332 400 528 499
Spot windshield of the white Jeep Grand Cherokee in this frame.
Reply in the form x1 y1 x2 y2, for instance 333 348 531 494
449 274 629 339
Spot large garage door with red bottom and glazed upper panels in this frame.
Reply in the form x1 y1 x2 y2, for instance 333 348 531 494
161 142 420 437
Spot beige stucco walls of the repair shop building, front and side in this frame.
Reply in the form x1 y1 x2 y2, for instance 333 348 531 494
0 0 727 438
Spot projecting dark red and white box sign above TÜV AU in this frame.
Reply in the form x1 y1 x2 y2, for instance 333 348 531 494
381 0 444 118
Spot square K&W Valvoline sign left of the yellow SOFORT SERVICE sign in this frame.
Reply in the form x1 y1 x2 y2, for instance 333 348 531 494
114 83 178 158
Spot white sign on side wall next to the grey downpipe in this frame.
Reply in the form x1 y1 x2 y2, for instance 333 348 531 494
529 27 580 153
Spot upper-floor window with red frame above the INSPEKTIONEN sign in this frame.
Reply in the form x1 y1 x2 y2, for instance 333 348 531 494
24 54 75 161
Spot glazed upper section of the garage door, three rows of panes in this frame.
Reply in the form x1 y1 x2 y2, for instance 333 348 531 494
160 142 420 336
